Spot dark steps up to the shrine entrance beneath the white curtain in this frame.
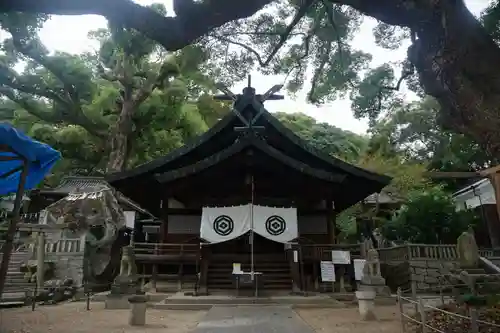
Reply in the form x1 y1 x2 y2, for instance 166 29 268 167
208 254 292 291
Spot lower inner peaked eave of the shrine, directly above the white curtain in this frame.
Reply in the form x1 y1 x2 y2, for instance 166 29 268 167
155 138 345 184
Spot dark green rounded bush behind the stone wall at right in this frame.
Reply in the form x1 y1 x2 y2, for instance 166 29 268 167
382 186 478 244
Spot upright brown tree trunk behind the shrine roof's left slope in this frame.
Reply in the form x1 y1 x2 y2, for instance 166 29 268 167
106 100 136 173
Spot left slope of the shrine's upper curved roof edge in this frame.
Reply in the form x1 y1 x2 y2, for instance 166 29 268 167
105 112 234 182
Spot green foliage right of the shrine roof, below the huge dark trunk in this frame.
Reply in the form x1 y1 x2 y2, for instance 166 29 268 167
369 97 500 186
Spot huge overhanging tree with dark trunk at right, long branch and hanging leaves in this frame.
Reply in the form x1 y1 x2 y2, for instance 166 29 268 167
0 0 500 156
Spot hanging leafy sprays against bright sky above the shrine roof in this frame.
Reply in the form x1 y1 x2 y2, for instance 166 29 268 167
207 0 419 121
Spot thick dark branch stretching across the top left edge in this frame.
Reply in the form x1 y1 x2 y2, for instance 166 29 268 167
0 0 273 51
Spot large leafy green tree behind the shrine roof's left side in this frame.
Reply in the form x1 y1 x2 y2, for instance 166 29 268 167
0 6 230 174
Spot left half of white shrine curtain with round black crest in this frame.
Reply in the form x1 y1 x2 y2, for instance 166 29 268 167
200 205 251 243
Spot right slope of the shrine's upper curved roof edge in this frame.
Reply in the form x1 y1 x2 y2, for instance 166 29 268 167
263 112 392 187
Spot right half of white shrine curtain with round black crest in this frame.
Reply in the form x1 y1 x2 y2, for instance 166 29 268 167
253 205 298 243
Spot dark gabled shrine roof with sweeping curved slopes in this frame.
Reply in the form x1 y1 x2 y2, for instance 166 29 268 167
105 97 391 208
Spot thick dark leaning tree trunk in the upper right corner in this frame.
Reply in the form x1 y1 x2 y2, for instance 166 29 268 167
331 0 500 157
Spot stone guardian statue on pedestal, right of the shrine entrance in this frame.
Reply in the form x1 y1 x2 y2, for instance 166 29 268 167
359 240 390 296
